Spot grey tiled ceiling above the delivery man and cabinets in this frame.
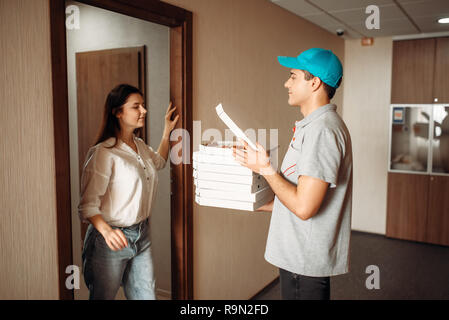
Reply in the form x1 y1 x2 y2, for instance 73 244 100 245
270 0 449 39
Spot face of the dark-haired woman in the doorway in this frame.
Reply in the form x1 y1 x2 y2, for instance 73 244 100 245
117 93 147 131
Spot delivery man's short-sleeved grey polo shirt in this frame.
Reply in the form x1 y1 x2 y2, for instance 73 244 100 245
265 104 352 277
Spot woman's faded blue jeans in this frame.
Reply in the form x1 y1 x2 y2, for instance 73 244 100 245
82 219 156 300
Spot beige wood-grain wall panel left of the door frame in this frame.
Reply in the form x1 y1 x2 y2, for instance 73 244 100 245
0 0 59 300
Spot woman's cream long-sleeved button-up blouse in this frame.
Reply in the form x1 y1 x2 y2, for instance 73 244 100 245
78 136 166 227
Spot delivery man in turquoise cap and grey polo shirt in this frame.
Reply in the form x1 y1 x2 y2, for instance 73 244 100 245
234 48 352 300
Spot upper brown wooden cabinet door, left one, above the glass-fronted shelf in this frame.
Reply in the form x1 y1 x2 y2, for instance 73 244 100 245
391 38 435 103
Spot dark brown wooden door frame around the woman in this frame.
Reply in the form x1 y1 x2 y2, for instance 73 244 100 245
49 0 193 300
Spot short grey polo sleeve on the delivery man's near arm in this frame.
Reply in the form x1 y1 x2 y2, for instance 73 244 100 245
296 129 343 188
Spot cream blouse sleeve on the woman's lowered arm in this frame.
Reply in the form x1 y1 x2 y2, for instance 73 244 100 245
78 147 112 223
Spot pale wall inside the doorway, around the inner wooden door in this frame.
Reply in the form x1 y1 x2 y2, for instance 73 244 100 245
67 1 171 299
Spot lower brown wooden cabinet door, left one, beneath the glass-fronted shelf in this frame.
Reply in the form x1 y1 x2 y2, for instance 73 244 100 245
386 173 429 241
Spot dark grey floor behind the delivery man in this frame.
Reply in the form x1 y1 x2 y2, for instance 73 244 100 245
254 231 449 300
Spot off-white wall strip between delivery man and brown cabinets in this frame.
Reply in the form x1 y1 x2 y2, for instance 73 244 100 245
343 38 393 234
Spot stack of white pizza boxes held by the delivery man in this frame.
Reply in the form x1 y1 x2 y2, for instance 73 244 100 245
193 142 274 211
